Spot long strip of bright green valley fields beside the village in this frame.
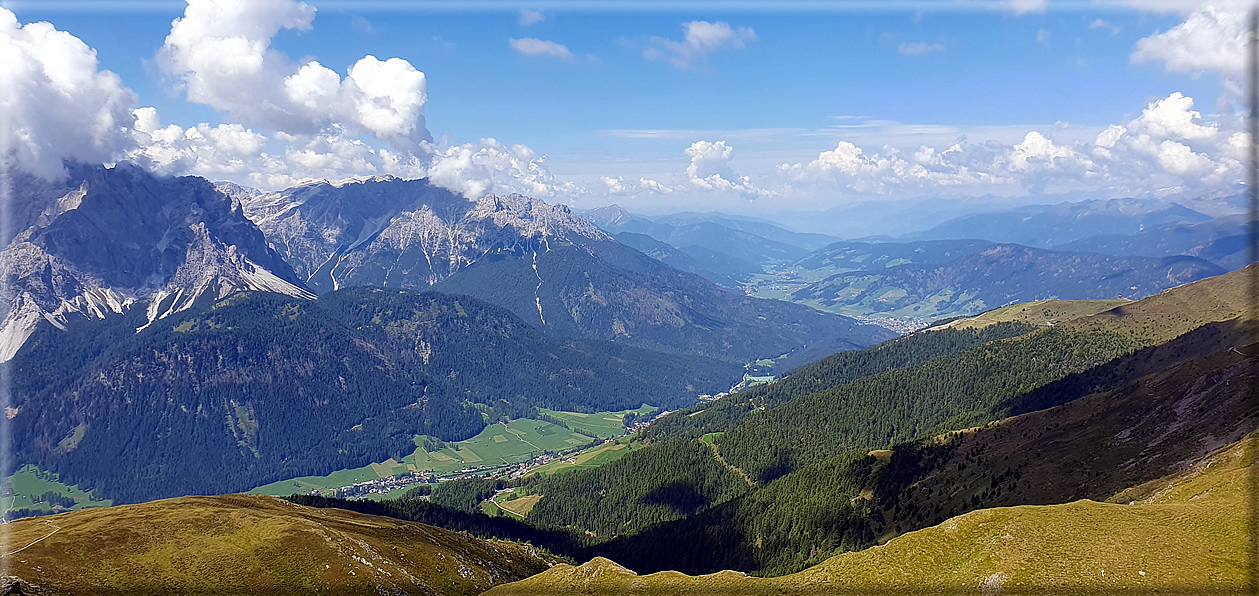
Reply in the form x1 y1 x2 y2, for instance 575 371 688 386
251 406 656 498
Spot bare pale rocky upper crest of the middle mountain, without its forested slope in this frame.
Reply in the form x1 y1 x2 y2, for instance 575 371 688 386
240 176 608 292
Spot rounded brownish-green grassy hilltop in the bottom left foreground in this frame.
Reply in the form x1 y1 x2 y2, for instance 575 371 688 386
5 495 556 595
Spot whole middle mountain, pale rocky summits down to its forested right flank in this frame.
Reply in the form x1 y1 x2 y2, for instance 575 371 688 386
242 176 891 363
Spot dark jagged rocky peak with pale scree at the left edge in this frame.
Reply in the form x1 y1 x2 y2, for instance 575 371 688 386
0 164 313 360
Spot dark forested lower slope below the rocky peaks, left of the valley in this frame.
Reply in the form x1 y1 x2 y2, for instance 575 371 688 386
10 289 740 501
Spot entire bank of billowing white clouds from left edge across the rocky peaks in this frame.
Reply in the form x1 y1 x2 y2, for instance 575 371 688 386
0 0 582 198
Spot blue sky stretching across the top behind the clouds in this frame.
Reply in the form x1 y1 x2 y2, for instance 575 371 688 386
3 1 1236 210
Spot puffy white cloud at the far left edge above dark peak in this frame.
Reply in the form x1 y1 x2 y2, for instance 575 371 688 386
0 8 137 179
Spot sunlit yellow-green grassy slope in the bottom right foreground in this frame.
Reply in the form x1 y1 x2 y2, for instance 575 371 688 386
487 430 1255 596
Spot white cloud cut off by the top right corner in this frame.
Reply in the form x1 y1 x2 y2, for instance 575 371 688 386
1131 4 1246 97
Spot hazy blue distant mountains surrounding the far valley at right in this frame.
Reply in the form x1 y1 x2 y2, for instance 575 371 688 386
582 197 1250 329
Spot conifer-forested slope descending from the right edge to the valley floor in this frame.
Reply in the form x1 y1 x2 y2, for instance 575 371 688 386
496 264 1249 572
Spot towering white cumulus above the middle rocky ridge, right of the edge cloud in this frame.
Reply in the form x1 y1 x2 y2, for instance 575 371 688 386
130 0 575 198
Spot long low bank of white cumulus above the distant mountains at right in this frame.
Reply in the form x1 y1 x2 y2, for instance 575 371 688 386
778 93 1249 195
